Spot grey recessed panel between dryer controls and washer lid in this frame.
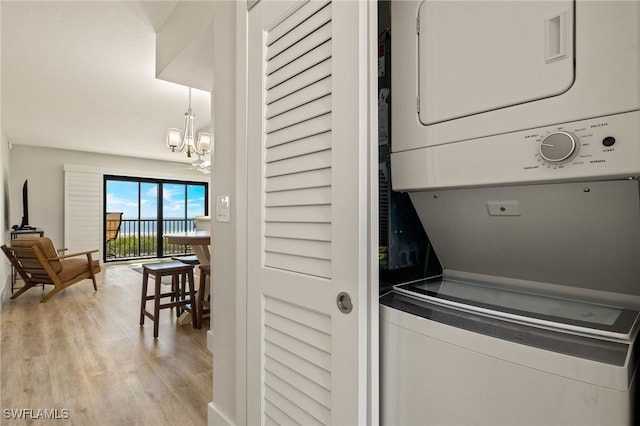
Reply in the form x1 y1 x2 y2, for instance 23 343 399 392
411 180 640 296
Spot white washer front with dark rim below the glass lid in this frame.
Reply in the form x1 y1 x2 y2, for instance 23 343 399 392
380 283 639 426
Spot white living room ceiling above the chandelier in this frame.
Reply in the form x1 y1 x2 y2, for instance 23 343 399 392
0 1 210 161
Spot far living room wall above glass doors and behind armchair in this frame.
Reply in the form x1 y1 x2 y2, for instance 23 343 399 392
9 145 209 247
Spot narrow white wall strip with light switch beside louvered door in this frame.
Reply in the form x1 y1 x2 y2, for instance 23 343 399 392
208 1 241 425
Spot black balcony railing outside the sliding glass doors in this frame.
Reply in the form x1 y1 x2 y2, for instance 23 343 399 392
105 219 195 262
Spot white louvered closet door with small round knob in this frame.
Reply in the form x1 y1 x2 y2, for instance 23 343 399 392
247 0 377 425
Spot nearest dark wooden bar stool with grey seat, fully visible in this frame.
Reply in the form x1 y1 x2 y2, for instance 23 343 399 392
140 262 196 339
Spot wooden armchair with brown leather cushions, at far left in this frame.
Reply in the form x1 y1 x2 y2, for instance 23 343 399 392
2 237 100 303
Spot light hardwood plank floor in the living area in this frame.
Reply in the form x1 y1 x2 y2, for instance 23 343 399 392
0 265 213 426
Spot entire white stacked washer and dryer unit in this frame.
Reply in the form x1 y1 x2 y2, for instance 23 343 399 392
381 0 640 425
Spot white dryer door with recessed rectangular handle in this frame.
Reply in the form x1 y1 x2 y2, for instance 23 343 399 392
417 0 575 125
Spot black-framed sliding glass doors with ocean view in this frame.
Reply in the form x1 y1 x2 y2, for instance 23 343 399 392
103 176 209 262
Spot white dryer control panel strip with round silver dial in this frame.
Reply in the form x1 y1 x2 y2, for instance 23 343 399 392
391 111 640 191
